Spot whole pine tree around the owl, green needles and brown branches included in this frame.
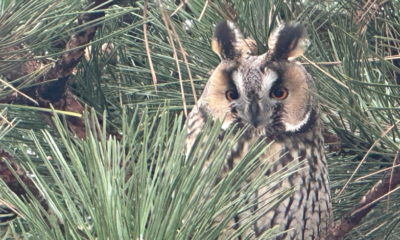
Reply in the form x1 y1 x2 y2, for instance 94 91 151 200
0 0 400 240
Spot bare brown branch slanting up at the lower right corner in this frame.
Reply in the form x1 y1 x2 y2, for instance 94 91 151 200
325 156 400 240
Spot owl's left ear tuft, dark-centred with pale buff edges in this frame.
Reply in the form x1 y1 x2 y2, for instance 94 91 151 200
212 21 251 60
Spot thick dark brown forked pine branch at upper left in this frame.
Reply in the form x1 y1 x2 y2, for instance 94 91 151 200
0 0 118 138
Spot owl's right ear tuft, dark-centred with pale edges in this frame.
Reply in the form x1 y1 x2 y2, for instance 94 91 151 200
268 23 310 61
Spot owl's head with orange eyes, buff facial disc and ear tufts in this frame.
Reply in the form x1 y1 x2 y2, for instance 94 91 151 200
200 21 317 135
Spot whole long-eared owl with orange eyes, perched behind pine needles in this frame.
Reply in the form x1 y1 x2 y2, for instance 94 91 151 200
186 21 333 240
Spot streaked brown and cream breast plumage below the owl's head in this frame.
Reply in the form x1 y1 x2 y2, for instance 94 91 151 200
225 134 332 240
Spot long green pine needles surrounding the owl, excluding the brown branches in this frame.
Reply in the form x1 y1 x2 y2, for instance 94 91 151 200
0 0 400 239
